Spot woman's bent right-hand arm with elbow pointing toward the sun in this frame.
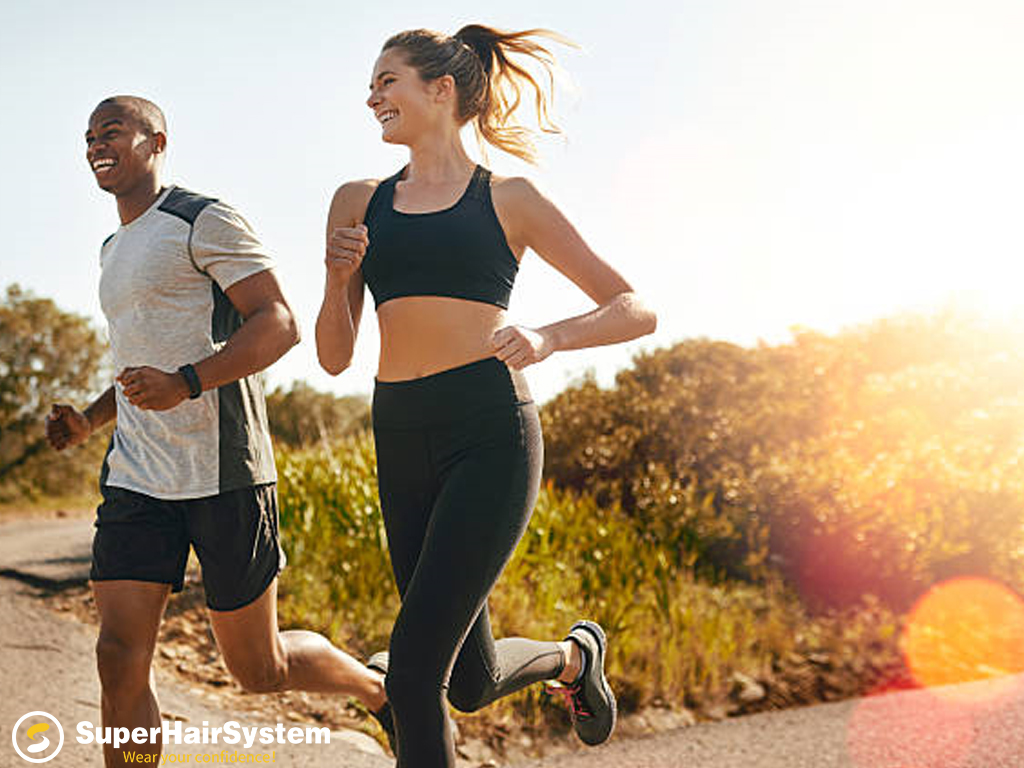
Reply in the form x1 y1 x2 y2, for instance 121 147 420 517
492 178 657 368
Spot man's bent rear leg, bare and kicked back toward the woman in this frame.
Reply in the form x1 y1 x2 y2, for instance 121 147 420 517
210 579 386 712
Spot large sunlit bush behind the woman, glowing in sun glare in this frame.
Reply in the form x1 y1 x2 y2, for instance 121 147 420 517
542 313 1024 607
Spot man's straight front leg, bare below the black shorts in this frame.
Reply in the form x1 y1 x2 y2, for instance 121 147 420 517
92 581 171 768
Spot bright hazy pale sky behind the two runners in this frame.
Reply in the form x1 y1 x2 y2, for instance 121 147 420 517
0 0 1024 400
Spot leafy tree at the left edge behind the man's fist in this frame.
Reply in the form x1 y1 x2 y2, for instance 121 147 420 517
0 285 104 497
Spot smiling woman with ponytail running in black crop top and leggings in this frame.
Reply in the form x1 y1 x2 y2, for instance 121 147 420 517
316 25 655 768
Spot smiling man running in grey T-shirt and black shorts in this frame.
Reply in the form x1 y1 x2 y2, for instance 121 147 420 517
46 96 388 766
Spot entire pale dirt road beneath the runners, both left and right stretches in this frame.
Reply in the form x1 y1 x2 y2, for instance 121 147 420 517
0 519 1024 768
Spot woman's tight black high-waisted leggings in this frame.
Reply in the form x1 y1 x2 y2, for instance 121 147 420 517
373 357 564 768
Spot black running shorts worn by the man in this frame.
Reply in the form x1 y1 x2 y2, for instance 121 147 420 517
89 482 285 610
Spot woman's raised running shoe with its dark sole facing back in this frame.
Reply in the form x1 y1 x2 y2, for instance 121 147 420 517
549 621 615 746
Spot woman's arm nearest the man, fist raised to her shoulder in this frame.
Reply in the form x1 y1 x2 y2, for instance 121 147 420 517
316 181 377 376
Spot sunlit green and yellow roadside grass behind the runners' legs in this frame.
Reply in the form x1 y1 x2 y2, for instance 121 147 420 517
278 434 899 748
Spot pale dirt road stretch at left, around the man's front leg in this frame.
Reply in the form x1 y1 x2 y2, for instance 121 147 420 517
0 518 393 768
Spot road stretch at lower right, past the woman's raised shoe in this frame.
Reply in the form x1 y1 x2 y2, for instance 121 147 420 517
515 677 1024 768
